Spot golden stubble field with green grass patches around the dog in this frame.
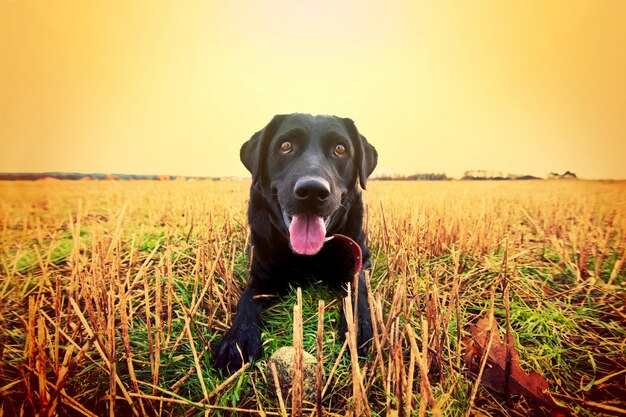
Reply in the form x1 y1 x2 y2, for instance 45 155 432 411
0 180 626 416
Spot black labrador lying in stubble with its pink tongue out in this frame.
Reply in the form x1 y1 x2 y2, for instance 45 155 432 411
215 114 378 373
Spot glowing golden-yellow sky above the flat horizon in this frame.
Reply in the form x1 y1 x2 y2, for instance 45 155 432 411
0 0 626 178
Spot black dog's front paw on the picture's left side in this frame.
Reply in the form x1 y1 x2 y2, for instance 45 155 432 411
214 325 263 374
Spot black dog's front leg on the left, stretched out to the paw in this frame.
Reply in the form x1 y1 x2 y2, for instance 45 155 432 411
214 285 263 374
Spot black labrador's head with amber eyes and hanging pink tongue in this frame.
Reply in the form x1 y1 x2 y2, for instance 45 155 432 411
241 114 378 255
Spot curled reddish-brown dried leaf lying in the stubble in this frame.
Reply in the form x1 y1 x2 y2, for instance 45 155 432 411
466 317 561 410
